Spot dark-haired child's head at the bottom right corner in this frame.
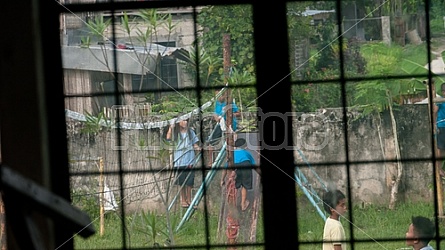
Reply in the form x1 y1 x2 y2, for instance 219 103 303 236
406 216 435 250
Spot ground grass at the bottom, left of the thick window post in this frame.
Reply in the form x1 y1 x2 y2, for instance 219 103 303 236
75 209 253 249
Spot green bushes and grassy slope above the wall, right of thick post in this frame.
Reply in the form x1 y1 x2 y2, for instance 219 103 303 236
292 39 443 113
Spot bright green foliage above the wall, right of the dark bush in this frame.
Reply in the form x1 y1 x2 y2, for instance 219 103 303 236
354 43 438 114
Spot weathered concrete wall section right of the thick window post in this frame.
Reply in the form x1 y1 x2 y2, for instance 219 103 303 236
295 105 433 204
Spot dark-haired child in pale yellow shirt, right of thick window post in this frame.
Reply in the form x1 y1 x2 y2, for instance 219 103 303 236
323 190 348 250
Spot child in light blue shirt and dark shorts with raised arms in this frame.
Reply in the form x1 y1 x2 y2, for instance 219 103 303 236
166 120 201 208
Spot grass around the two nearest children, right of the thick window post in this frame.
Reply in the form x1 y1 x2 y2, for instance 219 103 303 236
298 199 445 250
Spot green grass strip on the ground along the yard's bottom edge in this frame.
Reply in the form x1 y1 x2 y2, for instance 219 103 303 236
74 197 445 250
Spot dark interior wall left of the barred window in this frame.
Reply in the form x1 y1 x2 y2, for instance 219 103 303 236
0 0 72 249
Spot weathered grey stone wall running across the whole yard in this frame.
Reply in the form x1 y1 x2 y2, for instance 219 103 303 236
67 105 433 213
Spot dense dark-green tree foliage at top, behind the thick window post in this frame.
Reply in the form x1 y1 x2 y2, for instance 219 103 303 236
182 2 312 114
